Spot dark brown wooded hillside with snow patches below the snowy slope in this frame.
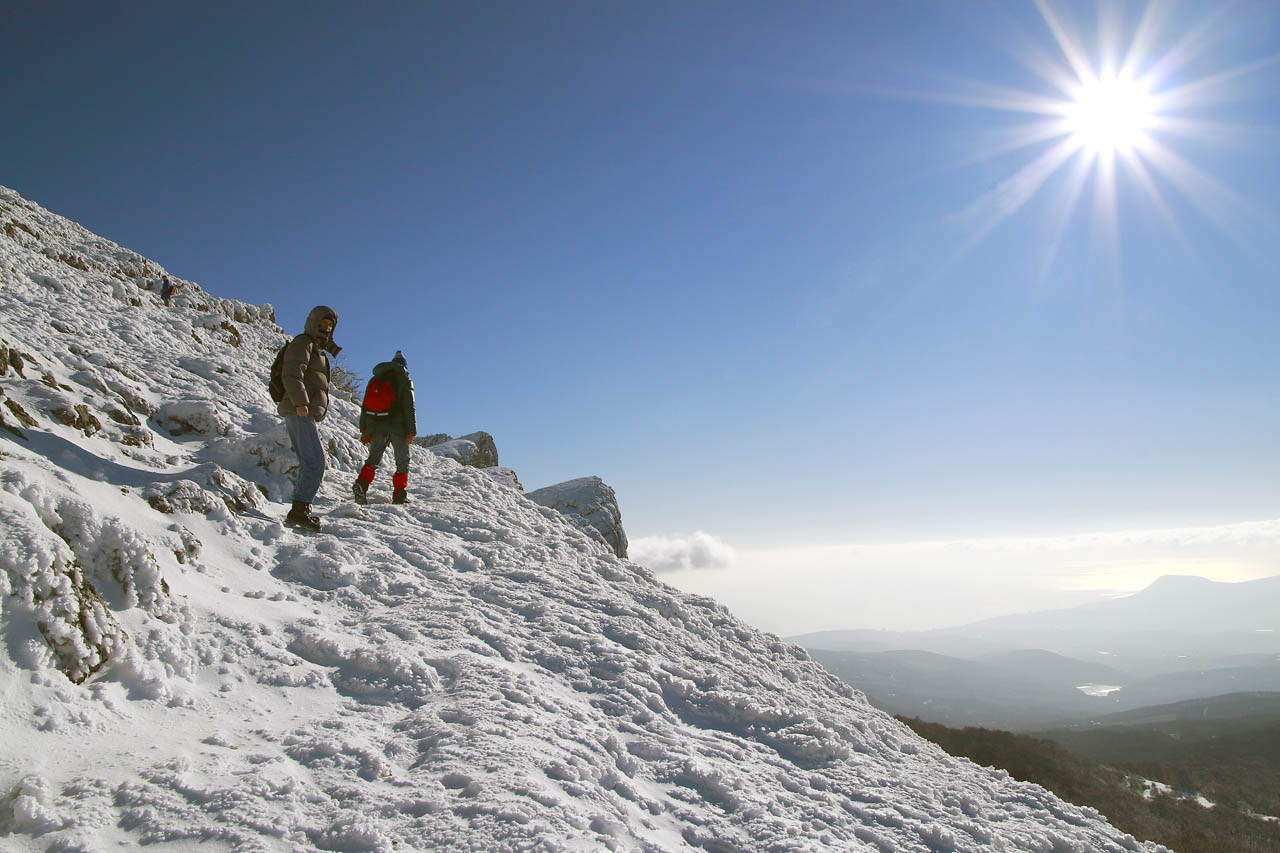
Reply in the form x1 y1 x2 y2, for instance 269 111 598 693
899 717 1280 853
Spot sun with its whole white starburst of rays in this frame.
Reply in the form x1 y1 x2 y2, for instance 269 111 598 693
952 0 1280 277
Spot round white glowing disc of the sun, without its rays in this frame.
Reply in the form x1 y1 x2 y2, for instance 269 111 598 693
1065 76 1155 155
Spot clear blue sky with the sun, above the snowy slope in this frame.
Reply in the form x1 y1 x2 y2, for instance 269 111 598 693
0 0 1280 630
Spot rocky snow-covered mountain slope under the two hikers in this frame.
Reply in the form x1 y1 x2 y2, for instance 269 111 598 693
0 188 1156 853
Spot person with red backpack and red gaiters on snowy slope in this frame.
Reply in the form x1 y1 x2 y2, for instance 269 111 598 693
351 350 417 503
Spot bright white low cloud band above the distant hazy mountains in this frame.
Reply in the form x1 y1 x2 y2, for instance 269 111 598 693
655 520 1280 637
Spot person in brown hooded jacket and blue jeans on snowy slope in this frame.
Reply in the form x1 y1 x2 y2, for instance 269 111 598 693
276 305 342 530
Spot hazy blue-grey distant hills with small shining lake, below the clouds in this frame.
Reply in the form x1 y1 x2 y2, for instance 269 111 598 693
790 576 1280 731
